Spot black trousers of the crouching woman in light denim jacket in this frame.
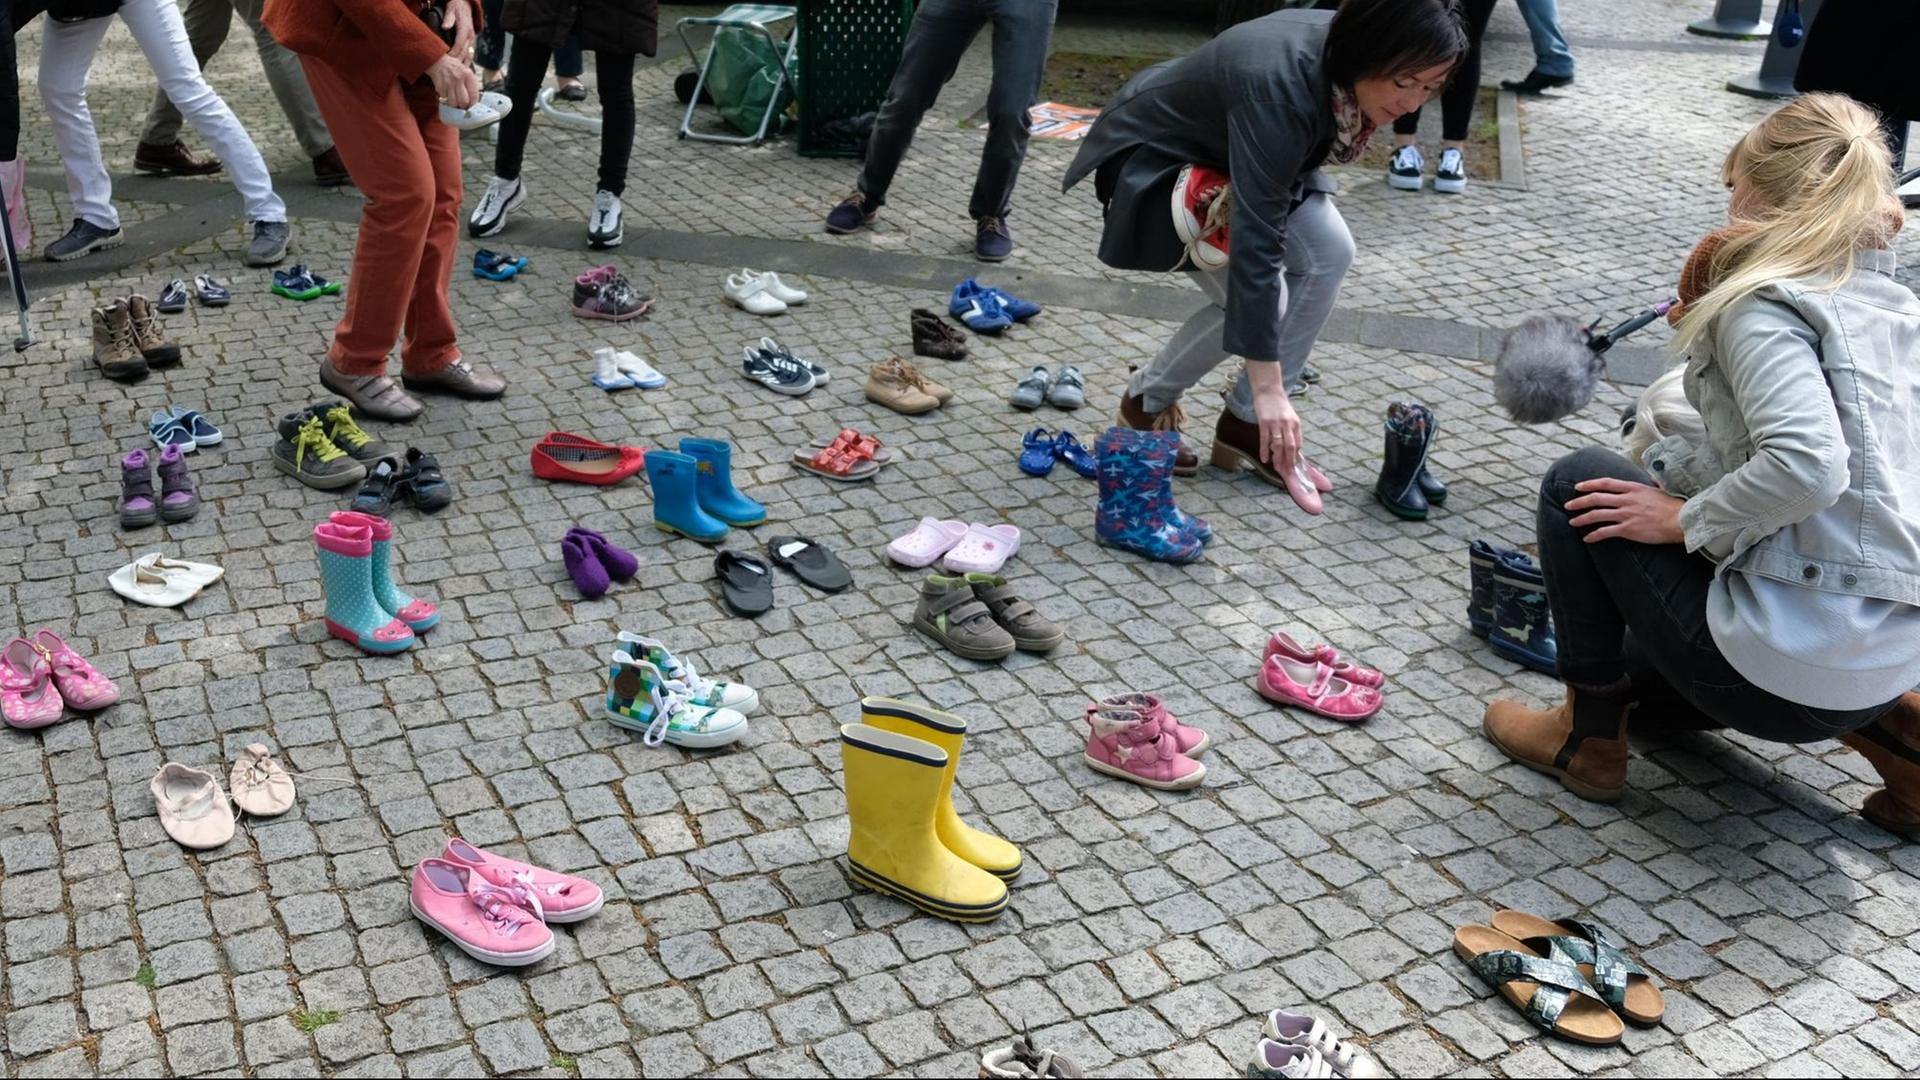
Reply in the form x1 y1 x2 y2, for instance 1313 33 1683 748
1538 446 1897 742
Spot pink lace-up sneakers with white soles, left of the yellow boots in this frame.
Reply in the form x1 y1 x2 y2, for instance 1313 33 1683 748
407 836 607 967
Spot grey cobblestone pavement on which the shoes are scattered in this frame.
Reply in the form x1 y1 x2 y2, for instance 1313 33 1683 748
0 0 1920 1076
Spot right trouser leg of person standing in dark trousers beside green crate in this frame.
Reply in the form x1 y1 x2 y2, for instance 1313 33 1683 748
968 0 1056 221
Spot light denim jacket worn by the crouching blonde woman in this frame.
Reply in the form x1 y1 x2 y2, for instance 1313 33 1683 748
1644 250 1920 605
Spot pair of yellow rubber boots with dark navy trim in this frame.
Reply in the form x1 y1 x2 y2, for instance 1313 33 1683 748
841 698 1021 922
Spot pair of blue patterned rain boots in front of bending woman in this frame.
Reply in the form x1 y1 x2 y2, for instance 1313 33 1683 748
1092 427 1202 563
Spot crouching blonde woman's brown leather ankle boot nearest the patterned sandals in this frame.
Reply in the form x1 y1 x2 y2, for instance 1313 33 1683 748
1480 686 1634 803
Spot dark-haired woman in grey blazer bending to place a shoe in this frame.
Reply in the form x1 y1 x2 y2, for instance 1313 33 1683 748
1066 0 1467 486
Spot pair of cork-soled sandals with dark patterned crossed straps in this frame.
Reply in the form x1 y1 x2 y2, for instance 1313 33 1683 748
1453 911 1667 1045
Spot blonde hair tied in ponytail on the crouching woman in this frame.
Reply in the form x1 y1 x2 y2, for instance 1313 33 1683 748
1674 94 1905 354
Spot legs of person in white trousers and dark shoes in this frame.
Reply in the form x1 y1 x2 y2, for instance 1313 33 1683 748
40 0 292 267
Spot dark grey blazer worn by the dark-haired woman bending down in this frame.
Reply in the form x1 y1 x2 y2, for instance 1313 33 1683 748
1062 12 1334 359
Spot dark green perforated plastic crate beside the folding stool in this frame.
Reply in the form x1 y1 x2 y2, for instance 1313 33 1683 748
799 0 914 158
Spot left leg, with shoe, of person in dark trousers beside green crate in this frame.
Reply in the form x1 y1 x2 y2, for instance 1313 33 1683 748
828 0 987 224
